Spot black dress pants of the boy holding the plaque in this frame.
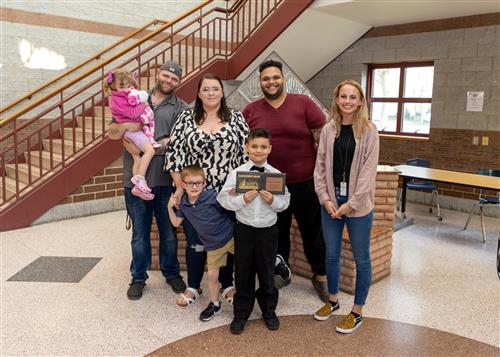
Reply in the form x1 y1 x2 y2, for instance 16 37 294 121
234 222 278 320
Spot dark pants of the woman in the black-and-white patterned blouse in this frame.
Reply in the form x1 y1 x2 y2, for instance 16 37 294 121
182 218 234 289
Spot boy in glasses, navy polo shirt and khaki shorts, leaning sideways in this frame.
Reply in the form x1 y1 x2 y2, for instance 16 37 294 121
168 165 234 321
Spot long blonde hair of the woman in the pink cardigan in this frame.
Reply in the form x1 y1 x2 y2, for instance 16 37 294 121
331 79 370 139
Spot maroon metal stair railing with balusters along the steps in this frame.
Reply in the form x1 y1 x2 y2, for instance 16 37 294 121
0 0 285 208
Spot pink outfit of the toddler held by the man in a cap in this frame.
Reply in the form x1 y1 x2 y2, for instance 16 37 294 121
109 90 160 147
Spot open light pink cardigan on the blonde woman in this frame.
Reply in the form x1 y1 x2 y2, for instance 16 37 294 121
314 120 379 217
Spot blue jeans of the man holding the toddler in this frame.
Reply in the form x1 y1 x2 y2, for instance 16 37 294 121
124 186 180 281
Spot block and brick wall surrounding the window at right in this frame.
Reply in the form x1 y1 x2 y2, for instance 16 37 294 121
308 16 500 199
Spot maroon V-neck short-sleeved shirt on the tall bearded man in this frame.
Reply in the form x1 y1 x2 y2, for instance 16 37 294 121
243 94 326 183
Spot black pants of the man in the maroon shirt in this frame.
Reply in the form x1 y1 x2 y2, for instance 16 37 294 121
277 179 326 275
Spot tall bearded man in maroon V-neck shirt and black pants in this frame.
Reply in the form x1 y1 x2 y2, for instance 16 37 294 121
243 60 328 301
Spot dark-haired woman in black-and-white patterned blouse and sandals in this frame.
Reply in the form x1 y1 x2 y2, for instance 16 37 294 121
164 74 249 307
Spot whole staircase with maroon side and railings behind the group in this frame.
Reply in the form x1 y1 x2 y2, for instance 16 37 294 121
0 0 312 231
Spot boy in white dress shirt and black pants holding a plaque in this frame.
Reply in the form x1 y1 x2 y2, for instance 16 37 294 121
217 128 290 334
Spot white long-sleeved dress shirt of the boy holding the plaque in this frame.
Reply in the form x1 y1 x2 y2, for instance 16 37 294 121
217 160 290 228
